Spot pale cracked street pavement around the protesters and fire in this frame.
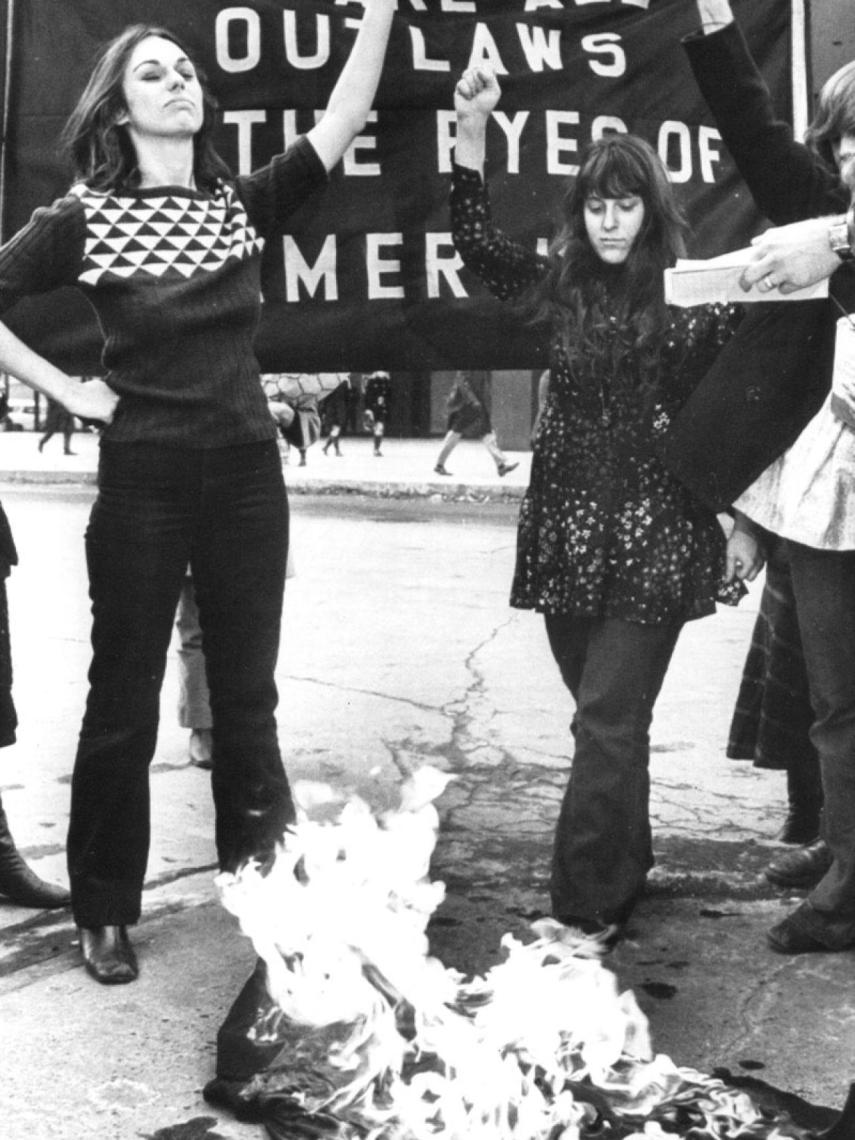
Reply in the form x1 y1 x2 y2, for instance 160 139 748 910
0 433 855 1140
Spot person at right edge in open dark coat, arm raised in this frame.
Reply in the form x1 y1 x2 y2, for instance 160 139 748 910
662 0 855 954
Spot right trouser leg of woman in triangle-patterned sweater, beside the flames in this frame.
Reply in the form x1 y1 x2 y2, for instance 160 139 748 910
192 445 294 870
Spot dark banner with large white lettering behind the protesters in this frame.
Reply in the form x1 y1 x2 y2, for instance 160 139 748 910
3 0 791 372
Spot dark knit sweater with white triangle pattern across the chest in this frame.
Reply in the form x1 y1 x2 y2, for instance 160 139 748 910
0 137 327 448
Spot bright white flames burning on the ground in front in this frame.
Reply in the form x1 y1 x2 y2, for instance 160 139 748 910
218 767 805 1140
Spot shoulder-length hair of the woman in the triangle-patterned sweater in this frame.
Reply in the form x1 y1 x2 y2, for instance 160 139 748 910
60 24 230 190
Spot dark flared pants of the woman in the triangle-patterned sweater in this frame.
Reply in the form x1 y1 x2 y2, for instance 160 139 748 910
67 441 294 927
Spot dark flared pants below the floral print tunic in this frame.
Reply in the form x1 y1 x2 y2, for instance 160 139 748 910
546 614 681 922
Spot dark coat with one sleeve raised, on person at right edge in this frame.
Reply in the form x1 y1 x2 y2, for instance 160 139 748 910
661 24 855 511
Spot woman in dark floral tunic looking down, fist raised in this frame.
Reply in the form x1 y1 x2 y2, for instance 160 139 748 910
451 67 759 941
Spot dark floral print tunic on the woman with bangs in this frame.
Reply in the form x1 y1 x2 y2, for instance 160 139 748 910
451 166 744 625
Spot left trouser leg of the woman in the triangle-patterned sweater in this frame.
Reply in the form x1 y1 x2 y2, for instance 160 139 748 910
67 445 189 927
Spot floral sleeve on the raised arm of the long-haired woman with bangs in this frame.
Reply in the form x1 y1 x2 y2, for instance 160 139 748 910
451 163 547 301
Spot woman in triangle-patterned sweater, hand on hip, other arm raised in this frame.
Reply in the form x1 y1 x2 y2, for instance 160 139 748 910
0 0 394 984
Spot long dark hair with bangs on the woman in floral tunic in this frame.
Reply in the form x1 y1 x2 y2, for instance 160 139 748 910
523 133 686 359
